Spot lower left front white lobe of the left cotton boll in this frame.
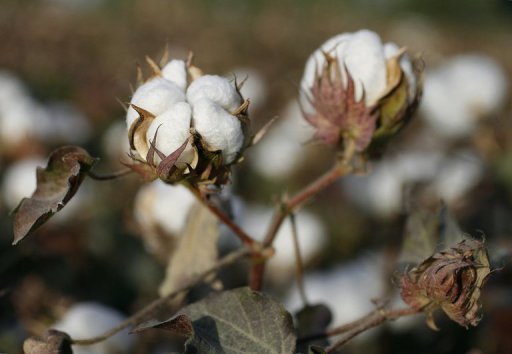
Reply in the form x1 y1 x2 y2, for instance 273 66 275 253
145 102 194 163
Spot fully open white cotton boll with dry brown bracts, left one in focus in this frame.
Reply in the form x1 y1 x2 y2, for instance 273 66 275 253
126 59 250 185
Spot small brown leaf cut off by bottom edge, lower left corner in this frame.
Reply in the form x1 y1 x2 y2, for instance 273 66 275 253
23 329 73 354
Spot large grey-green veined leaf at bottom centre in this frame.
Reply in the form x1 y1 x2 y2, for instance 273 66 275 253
134 288 296 354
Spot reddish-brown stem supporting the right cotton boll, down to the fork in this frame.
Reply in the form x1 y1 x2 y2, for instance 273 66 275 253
250 162 352 291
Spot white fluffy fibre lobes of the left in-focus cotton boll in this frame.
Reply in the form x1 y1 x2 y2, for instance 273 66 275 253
126 60 245 164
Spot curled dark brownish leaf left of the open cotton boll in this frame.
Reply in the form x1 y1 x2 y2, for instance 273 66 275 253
13 146 97 244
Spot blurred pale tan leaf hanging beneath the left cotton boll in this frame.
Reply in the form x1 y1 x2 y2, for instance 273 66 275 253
160 201 219 296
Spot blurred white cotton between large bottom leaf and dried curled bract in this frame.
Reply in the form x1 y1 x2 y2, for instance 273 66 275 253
284 254 385 327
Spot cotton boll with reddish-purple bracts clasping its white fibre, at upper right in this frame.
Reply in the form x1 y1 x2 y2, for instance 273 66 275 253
301 30 420 155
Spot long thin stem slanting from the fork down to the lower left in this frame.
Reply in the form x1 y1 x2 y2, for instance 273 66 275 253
71 248 250 345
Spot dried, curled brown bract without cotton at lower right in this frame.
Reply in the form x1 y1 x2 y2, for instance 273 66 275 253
400 239 491 329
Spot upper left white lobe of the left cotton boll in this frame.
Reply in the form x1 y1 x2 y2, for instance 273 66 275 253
126 77 186 129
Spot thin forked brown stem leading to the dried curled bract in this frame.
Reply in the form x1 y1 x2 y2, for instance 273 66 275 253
298 307 421 353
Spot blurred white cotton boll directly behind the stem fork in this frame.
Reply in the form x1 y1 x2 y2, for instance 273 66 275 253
242 206 327 281
